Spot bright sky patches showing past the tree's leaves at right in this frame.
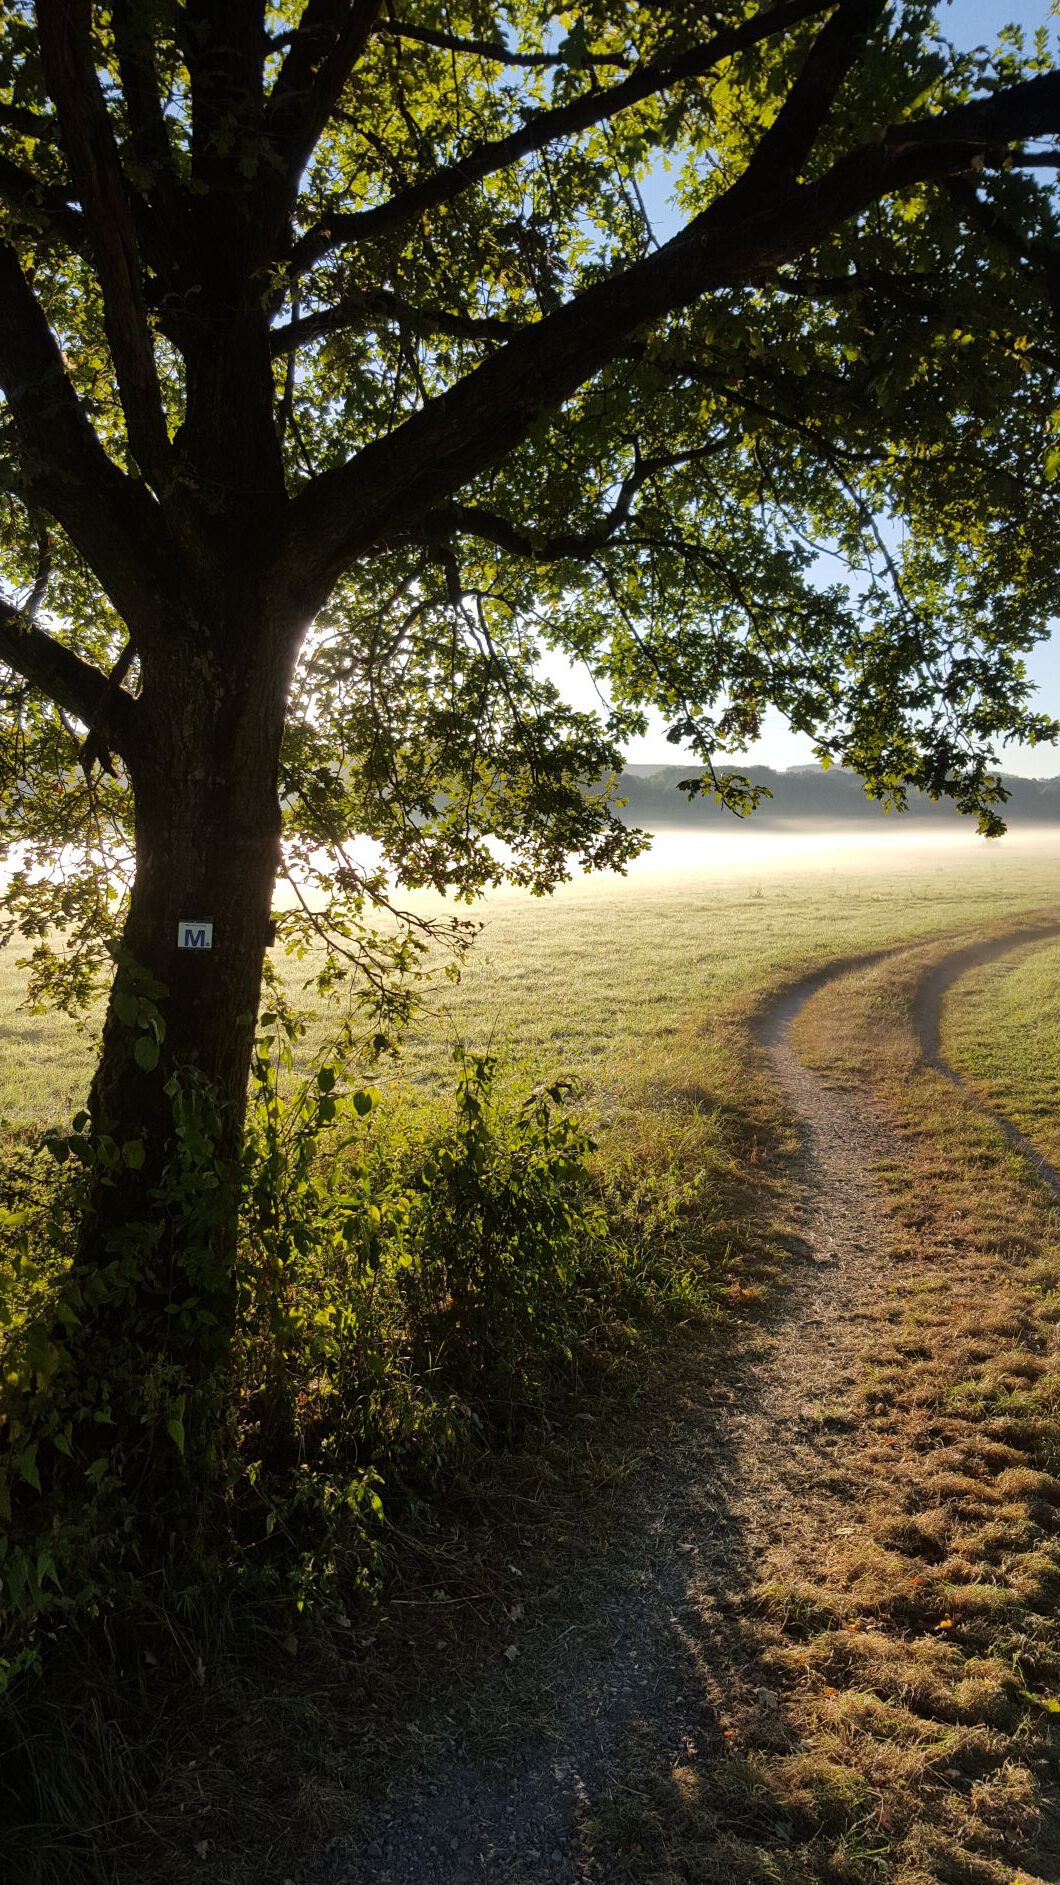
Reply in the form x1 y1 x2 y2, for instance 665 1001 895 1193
545 0 1060 779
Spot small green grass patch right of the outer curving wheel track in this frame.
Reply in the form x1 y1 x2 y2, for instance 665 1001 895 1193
943 927 1060 1165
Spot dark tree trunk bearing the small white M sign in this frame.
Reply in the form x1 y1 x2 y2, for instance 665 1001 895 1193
77 622 290 1425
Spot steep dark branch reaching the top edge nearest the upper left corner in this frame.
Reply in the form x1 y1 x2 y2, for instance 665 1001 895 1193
38 0 170 483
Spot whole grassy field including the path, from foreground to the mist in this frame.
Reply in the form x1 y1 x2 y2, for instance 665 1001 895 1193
10 826 1060 1885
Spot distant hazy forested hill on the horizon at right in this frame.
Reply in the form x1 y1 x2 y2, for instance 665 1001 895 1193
621 762 1060 829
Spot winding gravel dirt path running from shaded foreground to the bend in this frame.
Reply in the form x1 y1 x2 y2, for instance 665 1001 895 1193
313 937 1060 1885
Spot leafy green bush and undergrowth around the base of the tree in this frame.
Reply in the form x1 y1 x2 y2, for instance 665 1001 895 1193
0 1016 675 1674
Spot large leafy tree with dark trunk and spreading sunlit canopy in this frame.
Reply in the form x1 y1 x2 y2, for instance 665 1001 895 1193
0 0 1060 1387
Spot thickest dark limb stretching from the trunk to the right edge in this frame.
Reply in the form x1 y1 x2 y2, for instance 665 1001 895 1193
279 74 1060 596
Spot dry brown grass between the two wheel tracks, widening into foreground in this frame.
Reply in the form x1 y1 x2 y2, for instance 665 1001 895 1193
577 923 1060 1885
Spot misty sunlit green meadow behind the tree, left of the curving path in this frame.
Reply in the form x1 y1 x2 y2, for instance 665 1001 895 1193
0 824 1060 1125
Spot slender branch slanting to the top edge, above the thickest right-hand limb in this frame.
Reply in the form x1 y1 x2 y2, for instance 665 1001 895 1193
292 0 830 271
